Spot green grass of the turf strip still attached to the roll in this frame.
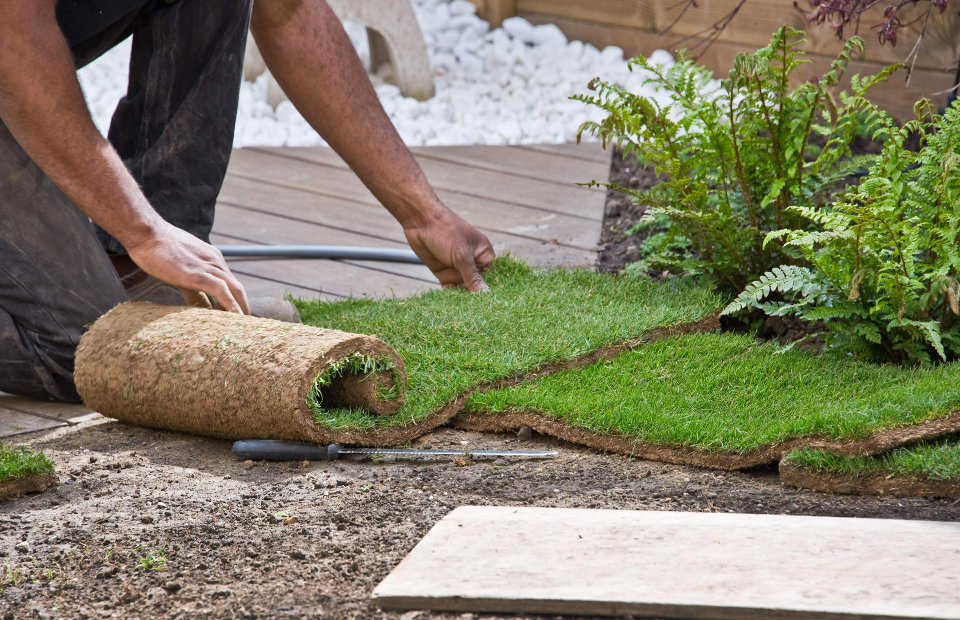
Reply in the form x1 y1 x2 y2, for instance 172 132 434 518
297 258 720 429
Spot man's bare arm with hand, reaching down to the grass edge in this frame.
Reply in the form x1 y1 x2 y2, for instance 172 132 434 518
251 0 494 291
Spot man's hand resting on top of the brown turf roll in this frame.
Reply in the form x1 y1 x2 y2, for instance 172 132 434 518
125 224 250 314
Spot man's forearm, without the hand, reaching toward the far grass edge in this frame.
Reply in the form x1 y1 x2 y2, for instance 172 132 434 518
252 0 442 227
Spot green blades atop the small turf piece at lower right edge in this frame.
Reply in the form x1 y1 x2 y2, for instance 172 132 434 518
787 439 960 480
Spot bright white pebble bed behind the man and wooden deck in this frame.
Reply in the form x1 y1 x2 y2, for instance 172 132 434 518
79 0 673 146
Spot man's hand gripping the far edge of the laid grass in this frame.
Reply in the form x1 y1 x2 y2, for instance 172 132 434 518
403 203 495 292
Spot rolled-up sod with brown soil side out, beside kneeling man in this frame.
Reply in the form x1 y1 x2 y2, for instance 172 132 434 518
74 302 407 441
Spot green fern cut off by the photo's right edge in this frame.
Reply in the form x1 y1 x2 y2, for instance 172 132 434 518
724 102 960 363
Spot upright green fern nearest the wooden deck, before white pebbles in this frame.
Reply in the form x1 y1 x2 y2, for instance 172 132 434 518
575 27 896 294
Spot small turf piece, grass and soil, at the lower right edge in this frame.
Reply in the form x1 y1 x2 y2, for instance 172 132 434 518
780 438 960 498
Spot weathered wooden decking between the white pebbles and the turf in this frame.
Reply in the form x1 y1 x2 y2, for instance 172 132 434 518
213 144 610 299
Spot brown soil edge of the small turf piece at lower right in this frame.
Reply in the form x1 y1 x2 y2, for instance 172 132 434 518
780 461 960 503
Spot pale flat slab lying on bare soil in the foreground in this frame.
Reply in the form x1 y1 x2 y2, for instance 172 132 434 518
373 506 960 619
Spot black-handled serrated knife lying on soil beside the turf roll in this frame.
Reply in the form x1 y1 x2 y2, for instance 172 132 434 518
233 439 557 461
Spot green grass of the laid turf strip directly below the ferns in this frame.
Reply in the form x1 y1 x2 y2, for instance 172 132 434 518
466 334 960 453
